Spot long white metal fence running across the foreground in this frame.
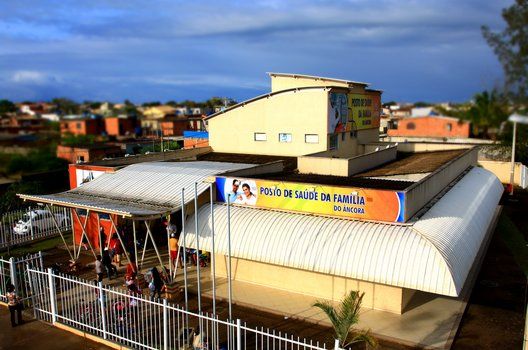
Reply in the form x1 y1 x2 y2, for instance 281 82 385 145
28 269 326 350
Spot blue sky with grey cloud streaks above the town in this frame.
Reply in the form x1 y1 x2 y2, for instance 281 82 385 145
0 0 512 102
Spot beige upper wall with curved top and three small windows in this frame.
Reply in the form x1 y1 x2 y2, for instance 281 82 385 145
208 89 328 156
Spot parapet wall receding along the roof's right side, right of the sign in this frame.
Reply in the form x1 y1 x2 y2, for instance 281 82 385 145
405 147 478 221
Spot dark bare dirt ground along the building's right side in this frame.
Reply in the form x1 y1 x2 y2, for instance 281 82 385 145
452 191 528 349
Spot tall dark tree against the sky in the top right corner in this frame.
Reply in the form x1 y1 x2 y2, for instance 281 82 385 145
482 0 528 107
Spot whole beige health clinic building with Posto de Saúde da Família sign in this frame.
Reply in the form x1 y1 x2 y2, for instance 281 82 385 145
21 73 503 314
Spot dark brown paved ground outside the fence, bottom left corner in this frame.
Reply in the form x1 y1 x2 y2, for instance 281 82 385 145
0 305 111 350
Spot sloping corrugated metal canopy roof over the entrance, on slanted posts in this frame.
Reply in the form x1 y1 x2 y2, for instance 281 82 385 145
19 161 254 216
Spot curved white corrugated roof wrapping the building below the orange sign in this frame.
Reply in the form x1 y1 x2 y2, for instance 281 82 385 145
186 168 503 296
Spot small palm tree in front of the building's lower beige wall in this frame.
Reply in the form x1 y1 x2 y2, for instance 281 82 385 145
312 290 377 348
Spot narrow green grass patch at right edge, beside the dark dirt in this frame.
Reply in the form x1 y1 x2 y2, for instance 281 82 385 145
497 213 528 277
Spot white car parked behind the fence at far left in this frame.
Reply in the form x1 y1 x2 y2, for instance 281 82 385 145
13 209 70 235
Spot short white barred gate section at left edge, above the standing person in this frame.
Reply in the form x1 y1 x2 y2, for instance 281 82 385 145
0 252 43 306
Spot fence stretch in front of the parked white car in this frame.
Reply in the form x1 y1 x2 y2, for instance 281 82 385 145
0 207 72 249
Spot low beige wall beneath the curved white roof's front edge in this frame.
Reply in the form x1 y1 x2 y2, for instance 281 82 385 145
215 255 414 314
